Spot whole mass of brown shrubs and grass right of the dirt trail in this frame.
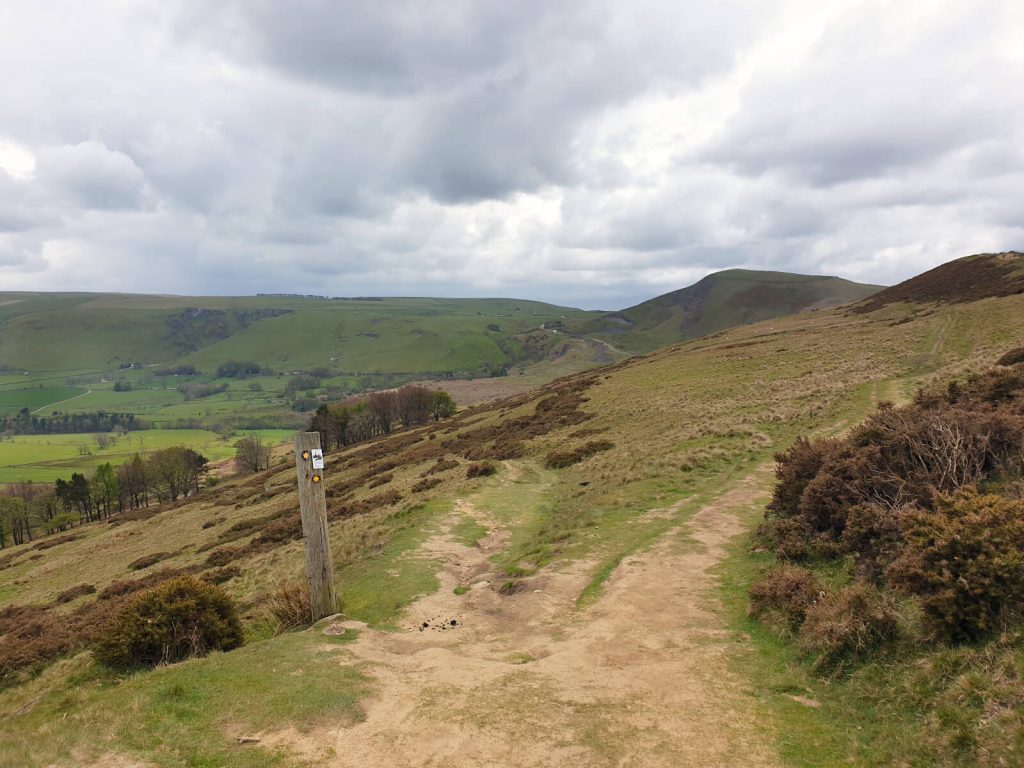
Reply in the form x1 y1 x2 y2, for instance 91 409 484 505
750 366 1024 766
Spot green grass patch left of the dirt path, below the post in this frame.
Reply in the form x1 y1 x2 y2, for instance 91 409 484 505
0 632 368 768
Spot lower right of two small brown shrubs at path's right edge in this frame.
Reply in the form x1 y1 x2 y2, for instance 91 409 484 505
800 583 901 671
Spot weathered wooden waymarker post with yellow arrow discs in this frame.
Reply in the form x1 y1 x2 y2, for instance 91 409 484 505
295 432 338 622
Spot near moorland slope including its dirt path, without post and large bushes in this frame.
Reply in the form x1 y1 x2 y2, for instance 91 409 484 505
0 253 1024 766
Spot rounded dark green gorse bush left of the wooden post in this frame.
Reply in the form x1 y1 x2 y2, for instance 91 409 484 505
93 575 244 669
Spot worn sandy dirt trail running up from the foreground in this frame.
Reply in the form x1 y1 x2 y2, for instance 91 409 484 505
268 467 776 768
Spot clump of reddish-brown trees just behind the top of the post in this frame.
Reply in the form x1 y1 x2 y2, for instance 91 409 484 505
309 384 456 449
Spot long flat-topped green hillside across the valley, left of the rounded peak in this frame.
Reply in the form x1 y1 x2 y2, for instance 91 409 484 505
0 293 598 373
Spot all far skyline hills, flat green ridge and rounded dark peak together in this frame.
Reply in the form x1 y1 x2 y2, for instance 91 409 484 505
0 270 878 374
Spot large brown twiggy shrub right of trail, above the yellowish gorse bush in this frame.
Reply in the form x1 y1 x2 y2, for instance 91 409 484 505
765 369 1024 561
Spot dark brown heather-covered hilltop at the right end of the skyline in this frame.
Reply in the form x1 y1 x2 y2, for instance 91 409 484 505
852 251 1024 314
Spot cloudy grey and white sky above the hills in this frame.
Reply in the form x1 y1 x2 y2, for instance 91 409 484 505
0 0 1024 309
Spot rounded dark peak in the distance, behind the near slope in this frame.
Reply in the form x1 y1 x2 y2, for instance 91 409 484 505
578 269 881 351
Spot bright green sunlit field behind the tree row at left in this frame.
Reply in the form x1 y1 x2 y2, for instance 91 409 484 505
0 429 294 484
